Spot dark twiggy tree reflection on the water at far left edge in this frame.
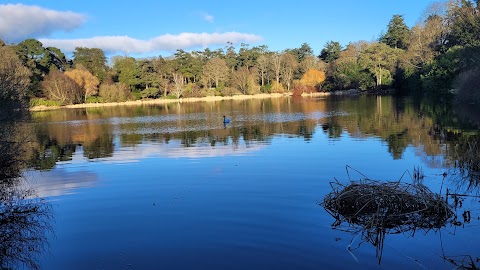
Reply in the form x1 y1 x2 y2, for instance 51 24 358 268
0 104 53 269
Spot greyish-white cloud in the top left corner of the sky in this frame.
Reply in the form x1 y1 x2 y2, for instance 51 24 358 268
0 4 86 43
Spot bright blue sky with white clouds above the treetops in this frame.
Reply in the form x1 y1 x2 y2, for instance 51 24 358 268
0 0 432 57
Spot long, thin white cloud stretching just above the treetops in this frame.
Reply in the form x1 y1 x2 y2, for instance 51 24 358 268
39 32 262 53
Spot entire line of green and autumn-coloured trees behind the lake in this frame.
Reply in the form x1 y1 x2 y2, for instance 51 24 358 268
0 0 480 107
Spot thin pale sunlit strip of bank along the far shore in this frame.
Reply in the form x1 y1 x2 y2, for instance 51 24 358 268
30 92 330 111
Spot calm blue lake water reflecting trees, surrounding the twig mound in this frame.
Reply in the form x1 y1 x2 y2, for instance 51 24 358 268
16 96 480 270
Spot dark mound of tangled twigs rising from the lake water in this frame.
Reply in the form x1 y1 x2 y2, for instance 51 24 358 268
321 179 454 233
